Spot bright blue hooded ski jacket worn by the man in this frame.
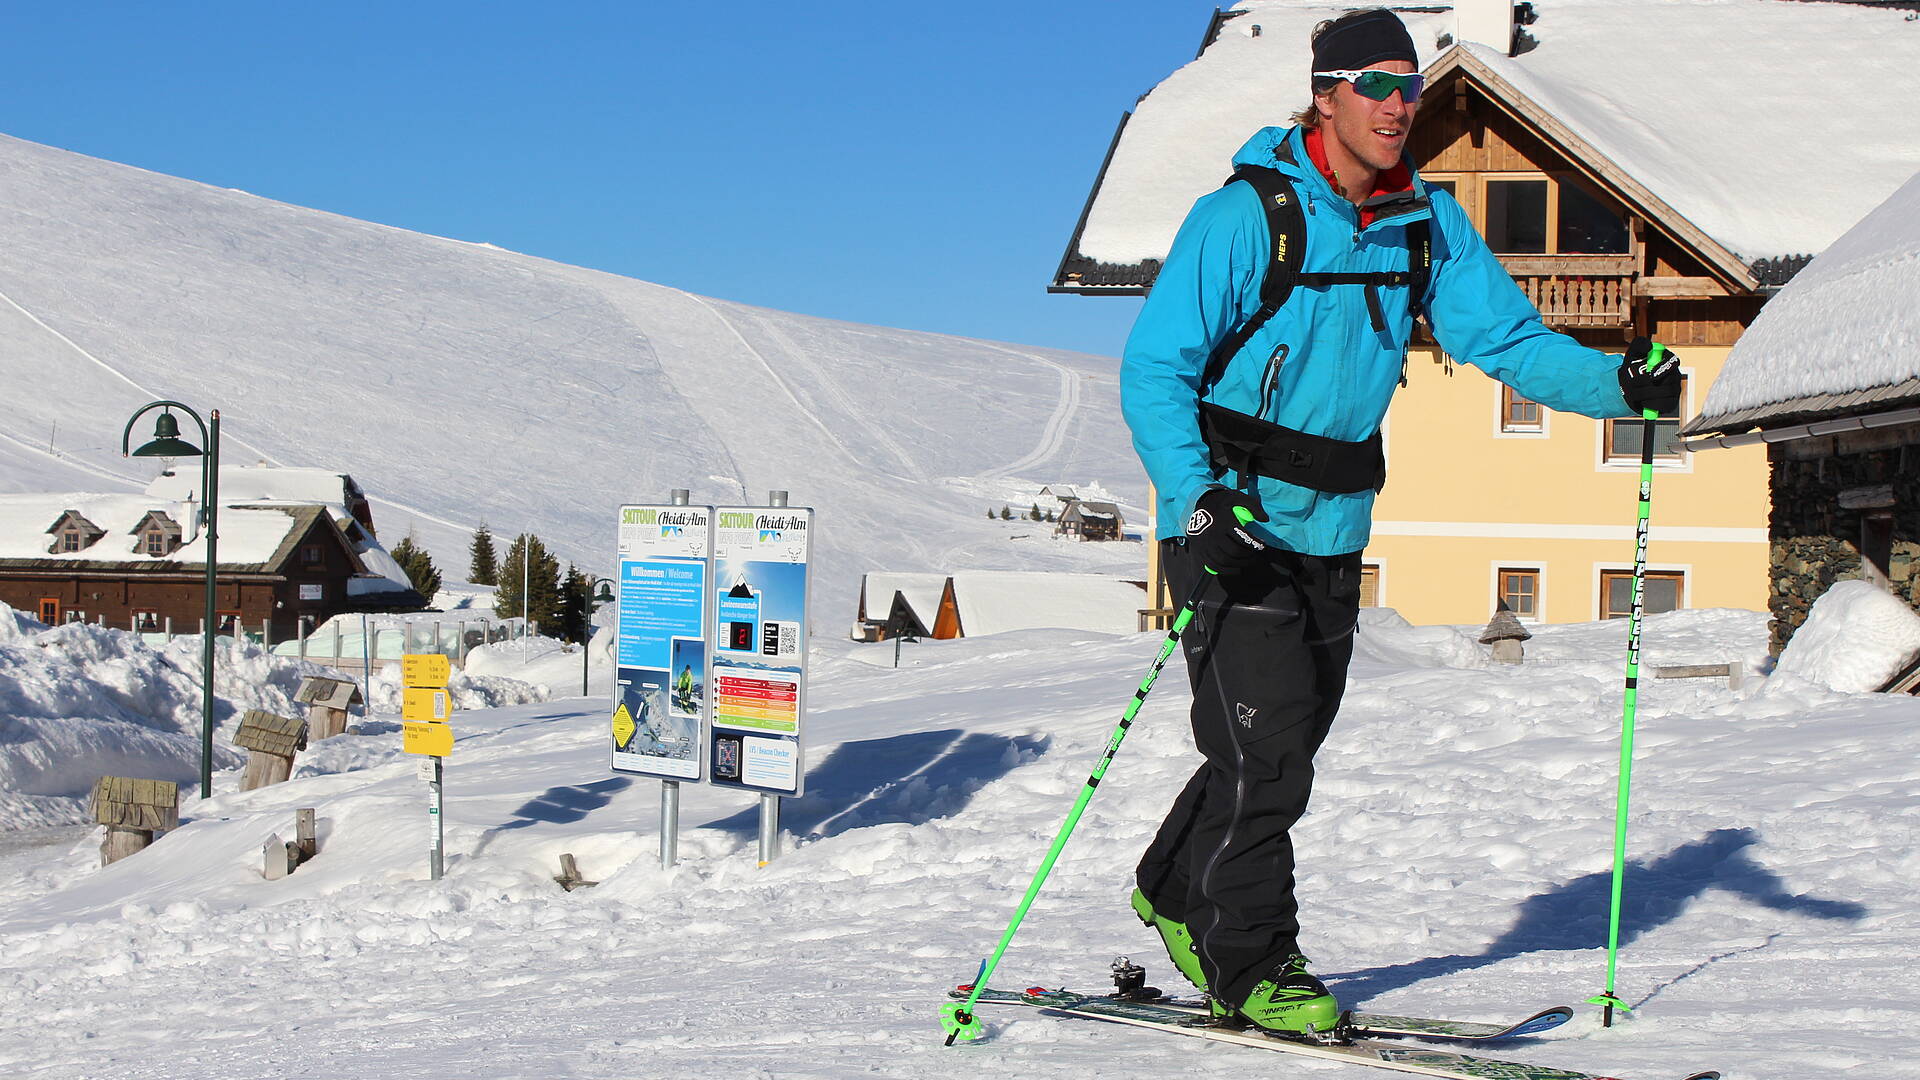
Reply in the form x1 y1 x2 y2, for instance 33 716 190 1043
1119 127 1632 555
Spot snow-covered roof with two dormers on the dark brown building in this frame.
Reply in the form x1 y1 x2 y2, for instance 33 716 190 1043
0 492 318 567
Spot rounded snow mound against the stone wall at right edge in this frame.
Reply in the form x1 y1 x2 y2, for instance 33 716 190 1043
1774 580 1920 694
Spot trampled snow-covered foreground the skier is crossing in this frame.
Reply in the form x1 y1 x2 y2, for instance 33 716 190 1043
0 599 1920 1080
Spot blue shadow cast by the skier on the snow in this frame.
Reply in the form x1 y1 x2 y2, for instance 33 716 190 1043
1327 828 1866 1003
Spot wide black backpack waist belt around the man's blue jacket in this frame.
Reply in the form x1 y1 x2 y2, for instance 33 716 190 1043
1200 402 1386 496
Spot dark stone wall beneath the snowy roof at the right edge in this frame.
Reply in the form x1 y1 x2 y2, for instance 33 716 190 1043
1766 440 1920 655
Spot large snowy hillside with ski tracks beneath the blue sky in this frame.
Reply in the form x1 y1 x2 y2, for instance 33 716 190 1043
0 136 1144 625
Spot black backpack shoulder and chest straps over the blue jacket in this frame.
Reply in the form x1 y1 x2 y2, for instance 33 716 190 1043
1200 165 1432 398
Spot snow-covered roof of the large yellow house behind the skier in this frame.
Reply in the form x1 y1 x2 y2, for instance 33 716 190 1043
1079 0 1920 263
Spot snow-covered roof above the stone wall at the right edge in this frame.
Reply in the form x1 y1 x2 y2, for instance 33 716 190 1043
1688 168 1920 432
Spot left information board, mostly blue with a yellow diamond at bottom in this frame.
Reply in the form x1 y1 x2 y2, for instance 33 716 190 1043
609 505 712 780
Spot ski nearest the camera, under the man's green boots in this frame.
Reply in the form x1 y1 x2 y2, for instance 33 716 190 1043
952 986 1720 1080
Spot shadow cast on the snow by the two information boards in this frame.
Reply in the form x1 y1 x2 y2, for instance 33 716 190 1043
707 728 1048 840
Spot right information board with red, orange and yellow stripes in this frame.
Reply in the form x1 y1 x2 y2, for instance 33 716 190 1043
708 505 814 796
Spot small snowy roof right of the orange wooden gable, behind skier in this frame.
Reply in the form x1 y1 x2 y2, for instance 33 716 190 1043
952 571 1146 638
